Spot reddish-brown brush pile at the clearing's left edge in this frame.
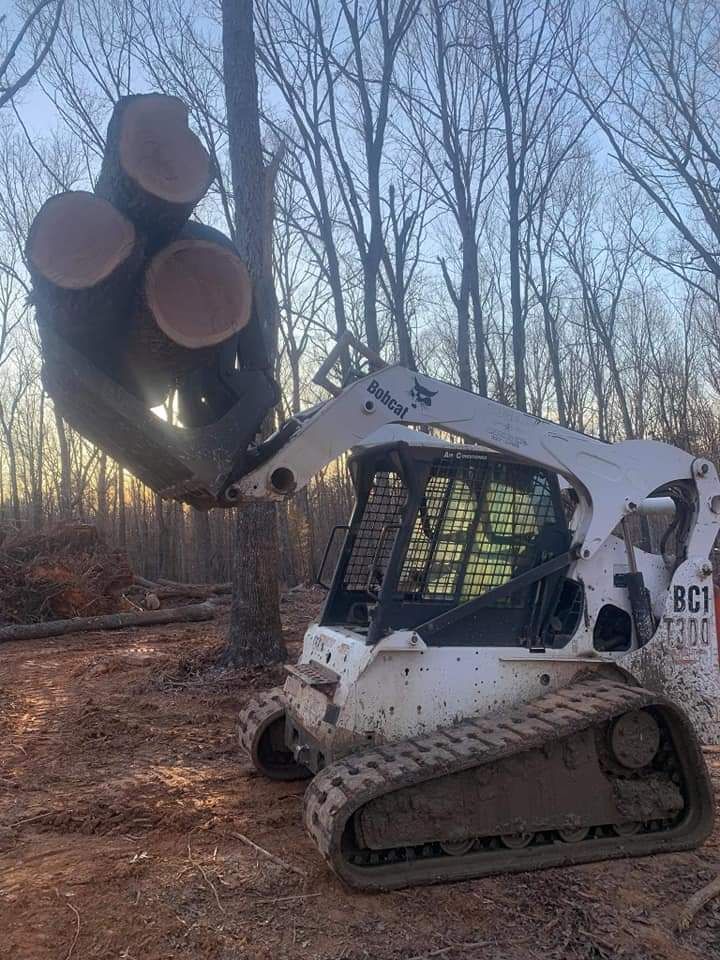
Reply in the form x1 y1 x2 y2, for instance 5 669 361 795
0 522 133 626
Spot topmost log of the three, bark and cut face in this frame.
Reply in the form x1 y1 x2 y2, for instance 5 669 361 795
96 93 214 248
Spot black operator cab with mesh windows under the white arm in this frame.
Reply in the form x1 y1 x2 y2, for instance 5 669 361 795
320 441 583 649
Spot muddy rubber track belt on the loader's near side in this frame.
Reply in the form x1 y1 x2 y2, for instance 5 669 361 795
305 679 713 890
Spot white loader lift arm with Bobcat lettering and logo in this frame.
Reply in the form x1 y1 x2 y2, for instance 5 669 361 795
233 366 717 559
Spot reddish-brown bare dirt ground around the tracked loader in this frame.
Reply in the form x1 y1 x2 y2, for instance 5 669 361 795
0 591 720 960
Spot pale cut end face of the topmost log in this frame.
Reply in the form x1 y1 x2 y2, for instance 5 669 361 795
119 94 212 204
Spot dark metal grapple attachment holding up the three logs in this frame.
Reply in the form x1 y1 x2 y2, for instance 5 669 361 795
42 329 277 509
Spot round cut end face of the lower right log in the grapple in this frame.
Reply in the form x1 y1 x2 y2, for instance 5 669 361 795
145 238 252 349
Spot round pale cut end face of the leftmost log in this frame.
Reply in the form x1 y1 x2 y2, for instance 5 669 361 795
27 190 136 290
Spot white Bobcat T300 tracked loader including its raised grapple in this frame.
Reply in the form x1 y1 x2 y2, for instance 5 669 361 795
46 330 720 889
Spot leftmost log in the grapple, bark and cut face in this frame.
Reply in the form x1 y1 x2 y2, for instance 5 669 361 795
26 191 143 357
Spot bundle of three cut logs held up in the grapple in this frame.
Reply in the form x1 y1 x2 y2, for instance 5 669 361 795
26 93 252 407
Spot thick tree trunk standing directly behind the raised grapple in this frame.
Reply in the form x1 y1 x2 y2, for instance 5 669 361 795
222 0 285 665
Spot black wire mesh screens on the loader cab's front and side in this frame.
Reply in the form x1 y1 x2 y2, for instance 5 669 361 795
343 456 558 606
